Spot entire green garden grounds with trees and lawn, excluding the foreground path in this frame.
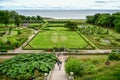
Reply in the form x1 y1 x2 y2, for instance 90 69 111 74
0 10 120 80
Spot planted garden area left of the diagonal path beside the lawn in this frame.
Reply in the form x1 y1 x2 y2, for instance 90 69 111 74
0 26 33 52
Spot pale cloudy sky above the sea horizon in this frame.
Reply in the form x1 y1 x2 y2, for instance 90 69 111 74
0 0 120 10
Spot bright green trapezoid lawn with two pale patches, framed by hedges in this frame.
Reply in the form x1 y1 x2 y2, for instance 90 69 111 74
29 27 87 48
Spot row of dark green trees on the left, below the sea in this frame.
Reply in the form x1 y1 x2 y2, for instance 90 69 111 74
0 10 43 26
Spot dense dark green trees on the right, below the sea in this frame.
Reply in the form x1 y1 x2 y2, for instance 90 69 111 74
86 12 120 33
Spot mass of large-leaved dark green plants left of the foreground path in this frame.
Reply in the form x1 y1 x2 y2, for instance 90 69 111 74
0 53 57 79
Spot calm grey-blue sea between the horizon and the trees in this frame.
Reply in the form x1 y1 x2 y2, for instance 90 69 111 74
16 10 120 19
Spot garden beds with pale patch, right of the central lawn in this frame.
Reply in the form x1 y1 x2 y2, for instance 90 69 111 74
79 25 120 49
